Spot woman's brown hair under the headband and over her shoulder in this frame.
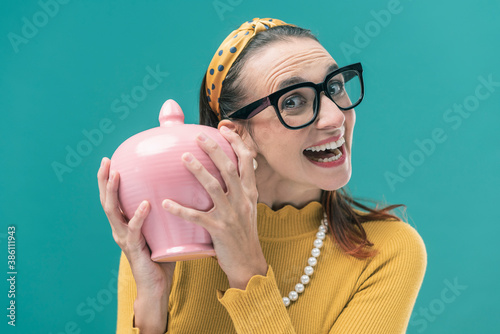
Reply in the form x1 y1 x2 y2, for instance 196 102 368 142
200 25 406 259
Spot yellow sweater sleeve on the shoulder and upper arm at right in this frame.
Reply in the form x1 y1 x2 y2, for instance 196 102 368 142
330 224 427 334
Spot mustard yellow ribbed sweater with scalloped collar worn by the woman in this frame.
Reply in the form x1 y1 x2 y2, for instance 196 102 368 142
117 202 427 334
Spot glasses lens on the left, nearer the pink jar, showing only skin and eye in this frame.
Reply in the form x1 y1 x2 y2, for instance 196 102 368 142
278 87 316 127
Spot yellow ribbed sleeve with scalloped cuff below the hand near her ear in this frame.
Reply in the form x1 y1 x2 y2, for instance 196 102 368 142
217 266 295 334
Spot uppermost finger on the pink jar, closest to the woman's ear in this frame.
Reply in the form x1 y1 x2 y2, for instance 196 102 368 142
220 126 257 195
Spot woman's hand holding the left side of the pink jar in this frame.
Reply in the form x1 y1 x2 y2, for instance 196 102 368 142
97 158 175 297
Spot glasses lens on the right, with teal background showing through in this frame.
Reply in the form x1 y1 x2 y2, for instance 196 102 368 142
327 70 361 109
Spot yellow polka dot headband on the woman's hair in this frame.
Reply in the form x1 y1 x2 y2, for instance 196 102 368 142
205 18 288 121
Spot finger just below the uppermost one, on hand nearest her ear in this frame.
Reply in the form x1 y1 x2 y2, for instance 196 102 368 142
196 133 243 196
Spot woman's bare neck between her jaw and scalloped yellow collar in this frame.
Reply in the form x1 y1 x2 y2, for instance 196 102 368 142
255 169 321 210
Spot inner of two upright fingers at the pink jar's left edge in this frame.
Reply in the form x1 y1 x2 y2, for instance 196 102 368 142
104 171 127 238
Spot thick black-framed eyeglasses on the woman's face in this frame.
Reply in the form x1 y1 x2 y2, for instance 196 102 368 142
229 63 364 130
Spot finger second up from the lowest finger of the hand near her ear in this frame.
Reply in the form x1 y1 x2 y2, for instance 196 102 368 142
182 152 228 205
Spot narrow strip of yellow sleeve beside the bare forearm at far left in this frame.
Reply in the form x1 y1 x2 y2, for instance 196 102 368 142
116 252 169 334
